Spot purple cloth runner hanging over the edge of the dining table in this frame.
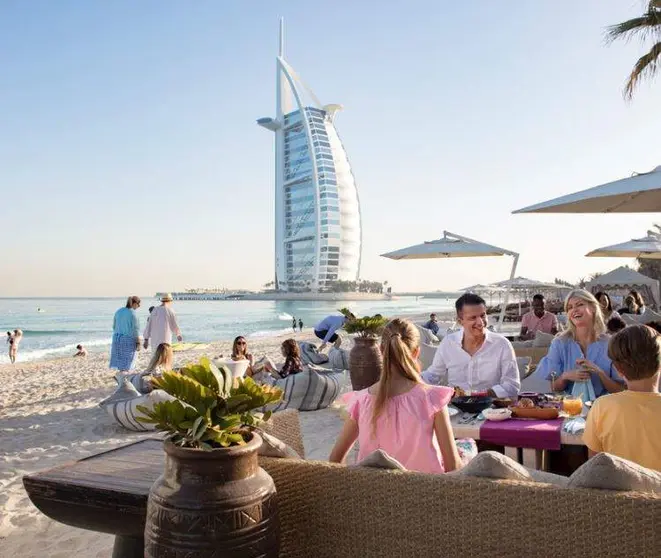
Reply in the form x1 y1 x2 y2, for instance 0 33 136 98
480 419 563 450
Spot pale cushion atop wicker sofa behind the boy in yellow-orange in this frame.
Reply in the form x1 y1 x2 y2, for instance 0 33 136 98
568 453 661 493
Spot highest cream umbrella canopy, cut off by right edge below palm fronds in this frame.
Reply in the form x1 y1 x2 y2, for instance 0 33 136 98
513 166 661 213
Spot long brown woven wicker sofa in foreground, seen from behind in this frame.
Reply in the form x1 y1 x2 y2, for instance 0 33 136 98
261 411 661 558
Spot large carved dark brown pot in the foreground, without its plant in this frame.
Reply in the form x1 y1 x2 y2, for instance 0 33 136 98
145 434 279 558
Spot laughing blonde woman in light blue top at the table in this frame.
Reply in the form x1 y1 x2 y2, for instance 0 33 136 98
544 289 624 397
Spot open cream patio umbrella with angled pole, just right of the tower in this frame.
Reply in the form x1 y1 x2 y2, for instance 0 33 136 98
381 231 519 330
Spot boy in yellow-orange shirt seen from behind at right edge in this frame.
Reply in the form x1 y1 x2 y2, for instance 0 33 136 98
583 325 661 471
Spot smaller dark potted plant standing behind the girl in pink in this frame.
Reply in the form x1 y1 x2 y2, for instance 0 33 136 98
342 309 388 390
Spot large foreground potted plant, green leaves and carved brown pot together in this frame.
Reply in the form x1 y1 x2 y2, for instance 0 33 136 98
138 358 282 558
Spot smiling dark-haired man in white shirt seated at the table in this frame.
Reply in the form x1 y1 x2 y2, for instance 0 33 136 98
422 293 521 397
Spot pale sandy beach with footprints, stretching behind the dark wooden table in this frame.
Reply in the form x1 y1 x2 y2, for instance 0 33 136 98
0 332 349 558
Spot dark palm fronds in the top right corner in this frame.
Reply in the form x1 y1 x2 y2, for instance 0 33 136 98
606 0 661 100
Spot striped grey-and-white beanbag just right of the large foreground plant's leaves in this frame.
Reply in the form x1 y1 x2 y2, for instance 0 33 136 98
266 370 344 411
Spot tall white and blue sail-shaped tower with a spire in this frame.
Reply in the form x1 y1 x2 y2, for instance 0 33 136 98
257 21 361 292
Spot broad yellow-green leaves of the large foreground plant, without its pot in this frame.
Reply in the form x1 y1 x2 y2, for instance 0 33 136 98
138 358 282 450
